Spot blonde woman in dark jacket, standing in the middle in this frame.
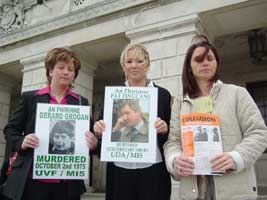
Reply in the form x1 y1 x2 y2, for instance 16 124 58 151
94 44 171 200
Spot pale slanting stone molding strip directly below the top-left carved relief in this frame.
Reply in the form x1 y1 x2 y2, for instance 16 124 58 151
0 0 158 47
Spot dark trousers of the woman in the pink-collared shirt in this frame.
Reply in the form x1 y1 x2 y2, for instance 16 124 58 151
22 179 80 200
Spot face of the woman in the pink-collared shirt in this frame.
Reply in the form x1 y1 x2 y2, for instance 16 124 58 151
49 61 75 87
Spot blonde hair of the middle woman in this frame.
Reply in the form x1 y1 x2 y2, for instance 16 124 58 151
120 44 150 68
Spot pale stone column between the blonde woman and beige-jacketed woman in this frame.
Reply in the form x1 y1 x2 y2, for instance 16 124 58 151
126 15 207 200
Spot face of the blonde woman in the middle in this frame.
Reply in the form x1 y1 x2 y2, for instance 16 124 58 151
123 50 148 83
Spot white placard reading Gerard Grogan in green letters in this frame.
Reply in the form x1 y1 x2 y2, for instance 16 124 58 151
33 103 90 179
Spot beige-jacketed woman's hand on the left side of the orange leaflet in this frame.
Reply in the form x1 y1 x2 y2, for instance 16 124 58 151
173 156 194 176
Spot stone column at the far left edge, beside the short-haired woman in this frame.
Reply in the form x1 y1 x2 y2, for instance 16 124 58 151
0 74 14 166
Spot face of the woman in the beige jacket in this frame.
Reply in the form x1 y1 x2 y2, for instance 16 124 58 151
191 47 218 81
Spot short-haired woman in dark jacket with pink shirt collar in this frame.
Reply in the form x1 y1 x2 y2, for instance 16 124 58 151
3 48 97 200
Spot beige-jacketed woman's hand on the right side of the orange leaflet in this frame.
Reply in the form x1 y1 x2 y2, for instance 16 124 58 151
211 152 236 172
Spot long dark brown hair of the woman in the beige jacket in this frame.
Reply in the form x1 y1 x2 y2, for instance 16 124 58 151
182 41 220 98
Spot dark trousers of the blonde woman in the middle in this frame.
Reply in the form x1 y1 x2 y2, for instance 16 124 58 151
106 162 171 200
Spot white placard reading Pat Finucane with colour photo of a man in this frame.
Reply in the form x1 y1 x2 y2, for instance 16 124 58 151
101 87 158 163
